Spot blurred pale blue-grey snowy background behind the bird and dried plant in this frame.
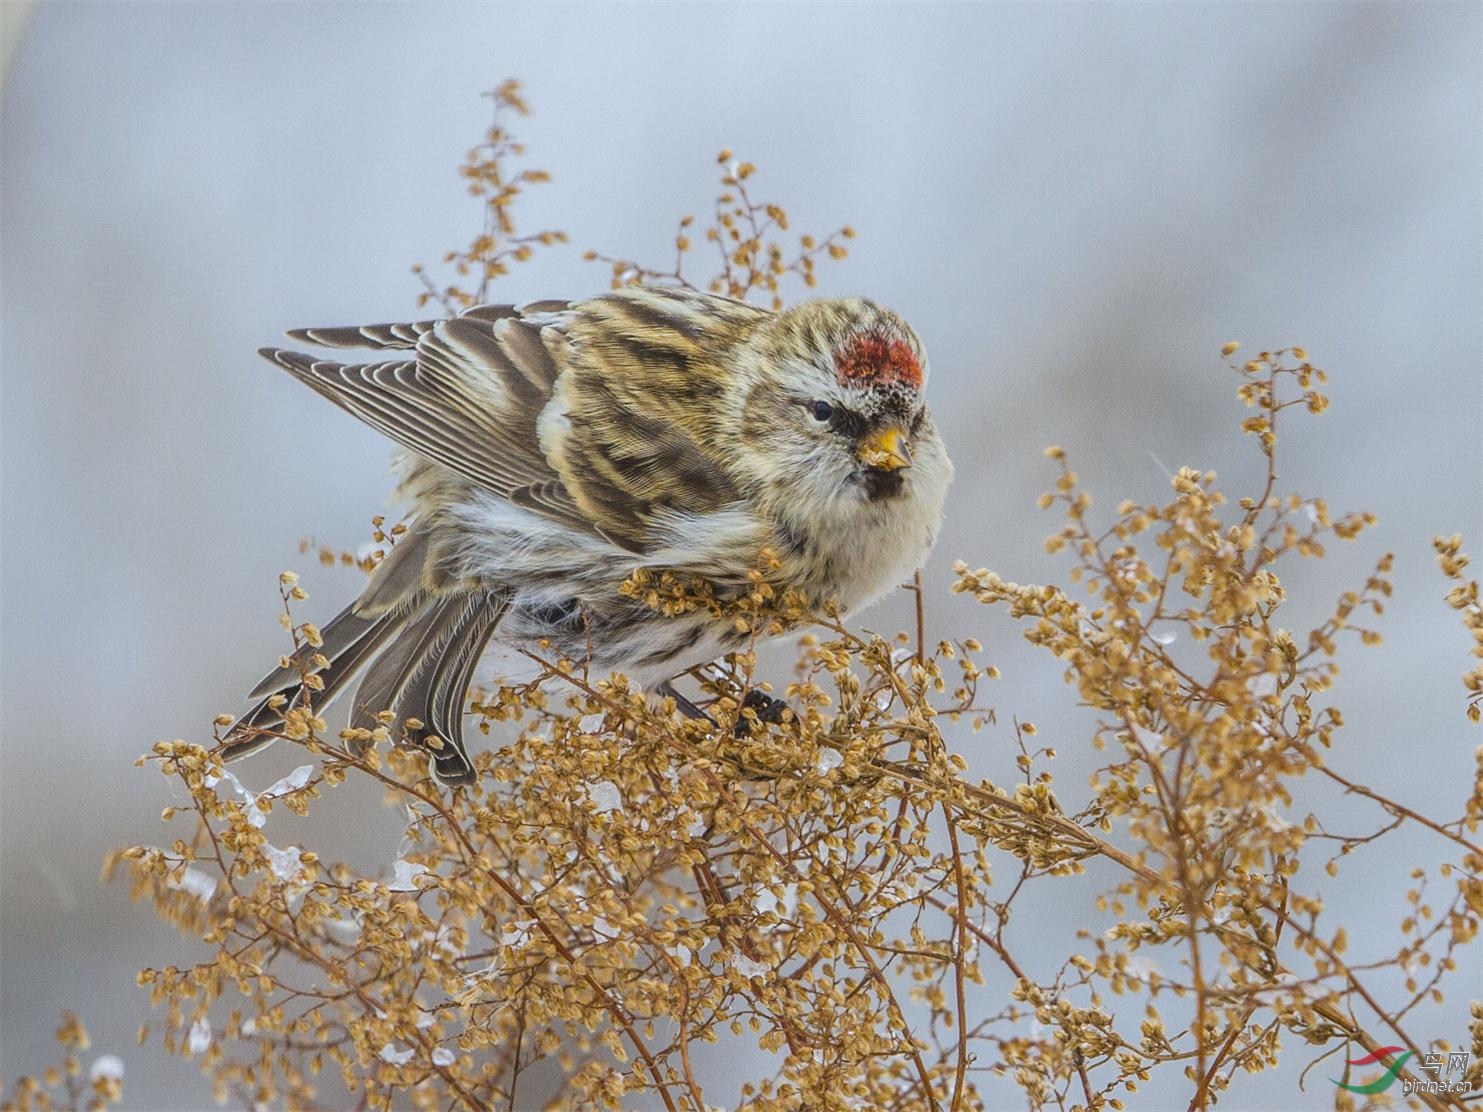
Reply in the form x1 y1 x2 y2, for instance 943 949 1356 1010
0 3 1483 1109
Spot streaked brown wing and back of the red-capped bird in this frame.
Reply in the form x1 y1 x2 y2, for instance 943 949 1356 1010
261 292 765 552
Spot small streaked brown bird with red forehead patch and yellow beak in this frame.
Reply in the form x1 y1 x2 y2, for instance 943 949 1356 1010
222 286 952 787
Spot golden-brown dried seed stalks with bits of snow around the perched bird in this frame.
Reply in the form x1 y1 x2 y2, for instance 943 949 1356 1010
8 82 1483 1109
